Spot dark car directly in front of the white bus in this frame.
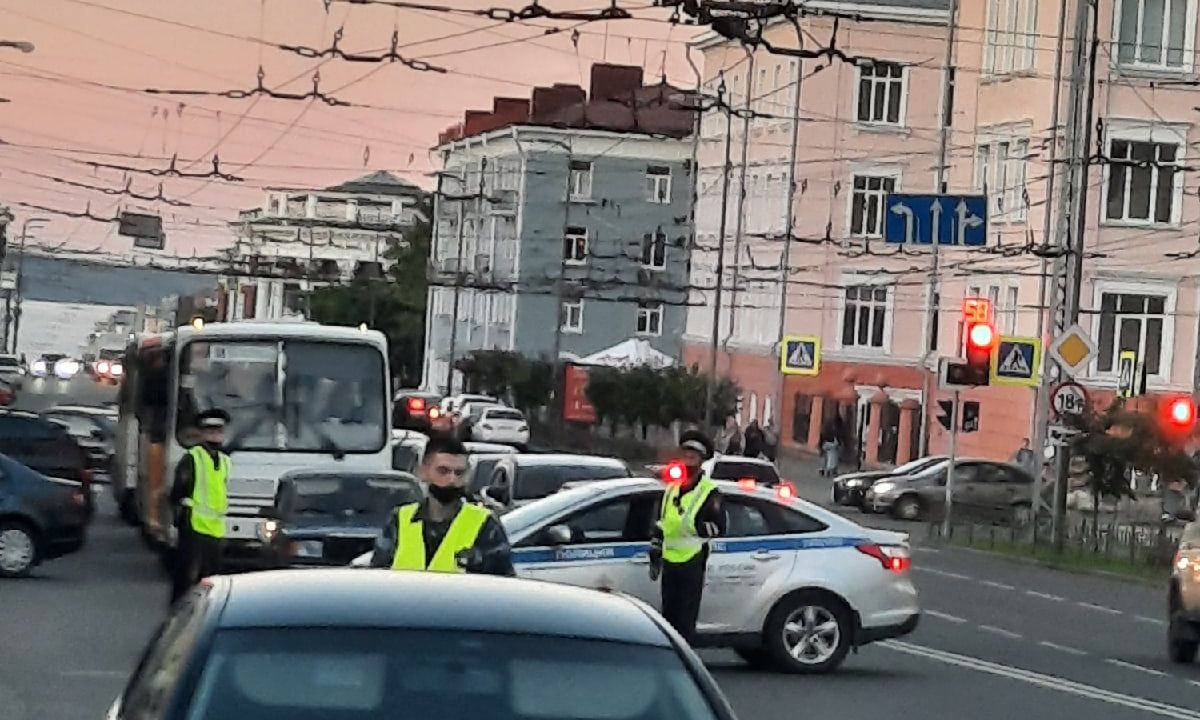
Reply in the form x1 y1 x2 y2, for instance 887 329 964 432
274 472 422 568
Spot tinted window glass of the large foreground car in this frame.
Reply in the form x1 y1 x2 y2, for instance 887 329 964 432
185 628 715 720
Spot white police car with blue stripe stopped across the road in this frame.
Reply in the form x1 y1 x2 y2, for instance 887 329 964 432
354 478 920 672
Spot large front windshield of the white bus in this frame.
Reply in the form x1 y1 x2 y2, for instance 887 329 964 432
175 340 388 455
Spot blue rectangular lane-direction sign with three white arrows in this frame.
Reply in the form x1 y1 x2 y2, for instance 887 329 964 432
883 193 988 247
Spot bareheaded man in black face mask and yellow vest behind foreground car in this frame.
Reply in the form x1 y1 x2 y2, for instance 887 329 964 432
371 437 516 576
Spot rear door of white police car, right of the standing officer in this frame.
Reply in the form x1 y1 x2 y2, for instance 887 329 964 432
698 493 796 632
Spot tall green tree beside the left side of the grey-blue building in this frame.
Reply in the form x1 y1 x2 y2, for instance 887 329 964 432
312 196 433 386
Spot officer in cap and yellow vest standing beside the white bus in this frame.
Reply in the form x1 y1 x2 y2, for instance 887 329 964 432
170 409 229 602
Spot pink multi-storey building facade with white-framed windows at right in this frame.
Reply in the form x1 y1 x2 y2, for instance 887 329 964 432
685 0 1200 464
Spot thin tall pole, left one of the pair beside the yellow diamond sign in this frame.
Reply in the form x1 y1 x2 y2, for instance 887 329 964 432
1030 0 1070 523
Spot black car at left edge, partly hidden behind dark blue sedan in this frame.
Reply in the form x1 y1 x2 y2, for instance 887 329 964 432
0 409 95 512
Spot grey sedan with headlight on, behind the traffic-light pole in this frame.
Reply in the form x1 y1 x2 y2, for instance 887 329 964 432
863 458 1033 521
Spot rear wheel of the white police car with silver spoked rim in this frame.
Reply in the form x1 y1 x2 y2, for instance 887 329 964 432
763 590 853 673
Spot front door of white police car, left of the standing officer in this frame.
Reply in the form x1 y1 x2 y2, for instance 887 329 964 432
512 493 654 598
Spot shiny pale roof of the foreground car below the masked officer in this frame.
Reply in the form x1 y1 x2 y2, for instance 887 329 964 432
212 568 670 647
